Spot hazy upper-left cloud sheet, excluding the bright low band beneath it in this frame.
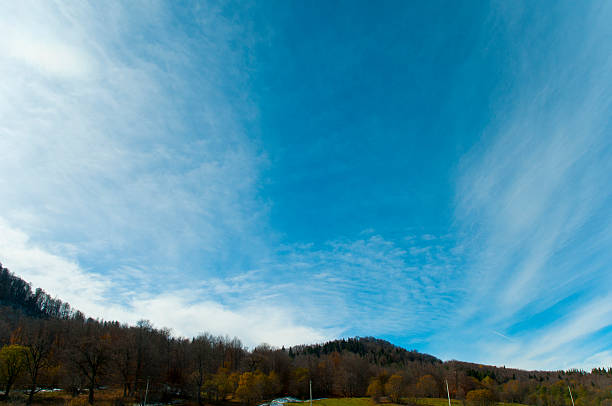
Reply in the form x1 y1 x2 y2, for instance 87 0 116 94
0 2 266 276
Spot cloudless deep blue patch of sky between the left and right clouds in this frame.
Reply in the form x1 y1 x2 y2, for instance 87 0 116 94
244 2 506 242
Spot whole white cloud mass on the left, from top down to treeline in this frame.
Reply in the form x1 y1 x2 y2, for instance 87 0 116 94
0 2 306 345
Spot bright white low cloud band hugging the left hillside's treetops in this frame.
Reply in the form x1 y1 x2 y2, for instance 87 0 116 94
0 217 340 348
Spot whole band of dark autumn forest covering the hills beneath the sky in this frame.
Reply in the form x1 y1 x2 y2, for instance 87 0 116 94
0 265 612 406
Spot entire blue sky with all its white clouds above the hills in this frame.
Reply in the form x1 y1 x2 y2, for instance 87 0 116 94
0 1 612 369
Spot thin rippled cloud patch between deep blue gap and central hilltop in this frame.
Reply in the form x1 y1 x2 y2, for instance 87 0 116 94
262 232 455 343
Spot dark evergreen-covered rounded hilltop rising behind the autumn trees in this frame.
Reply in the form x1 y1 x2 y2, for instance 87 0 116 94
289 337 442 367
